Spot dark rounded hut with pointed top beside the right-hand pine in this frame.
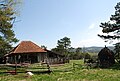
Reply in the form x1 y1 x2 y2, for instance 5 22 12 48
98 46 115 68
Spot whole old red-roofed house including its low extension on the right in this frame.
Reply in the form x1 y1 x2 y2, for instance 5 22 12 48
6 41 64 64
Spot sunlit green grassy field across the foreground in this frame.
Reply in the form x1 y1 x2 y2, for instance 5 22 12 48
0 60 120 81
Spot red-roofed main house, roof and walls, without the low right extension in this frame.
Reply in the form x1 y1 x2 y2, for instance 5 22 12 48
8 41 47 63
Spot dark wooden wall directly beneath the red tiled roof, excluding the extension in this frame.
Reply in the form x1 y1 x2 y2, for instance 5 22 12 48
8 53 47 63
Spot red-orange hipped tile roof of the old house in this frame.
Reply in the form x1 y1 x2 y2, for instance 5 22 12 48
11 41 47 53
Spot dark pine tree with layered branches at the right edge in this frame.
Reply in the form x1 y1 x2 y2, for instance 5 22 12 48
98 2 120 62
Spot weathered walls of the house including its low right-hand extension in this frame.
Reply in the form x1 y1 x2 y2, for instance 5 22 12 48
8 52 65 64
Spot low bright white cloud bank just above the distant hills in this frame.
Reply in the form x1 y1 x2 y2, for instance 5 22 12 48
72 35 115 47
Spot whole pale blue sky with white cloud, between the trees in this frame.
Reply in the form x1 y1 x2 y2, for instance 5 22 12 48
14 0 119 49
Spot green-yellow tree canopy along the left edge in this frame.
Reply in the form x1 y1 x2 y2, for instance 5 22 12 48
0 0 18 55
